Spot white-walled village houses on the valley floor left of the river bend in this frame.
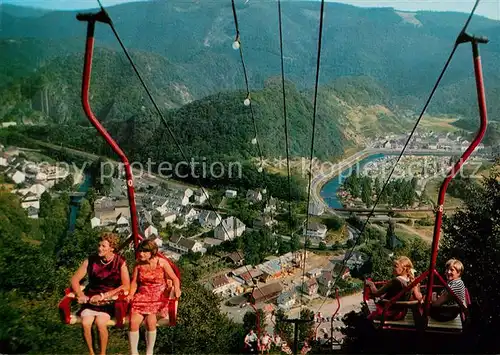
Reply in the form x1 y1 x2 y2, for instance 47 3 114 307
0 145 367 334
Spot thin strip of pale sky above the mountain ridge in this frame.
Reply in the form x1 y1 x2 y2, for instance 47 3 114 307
0 0 500 20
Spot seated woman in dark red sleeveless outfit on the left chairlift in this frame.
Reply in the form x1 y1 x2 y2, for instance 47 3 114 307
71 233 130 355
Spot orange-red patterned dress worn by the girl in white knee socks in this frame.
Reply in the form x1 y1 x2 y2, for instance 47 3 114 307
132 260 168 318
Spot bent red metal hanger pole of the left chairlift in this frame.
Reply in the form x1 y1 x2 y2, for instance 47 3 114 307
82 13 140 251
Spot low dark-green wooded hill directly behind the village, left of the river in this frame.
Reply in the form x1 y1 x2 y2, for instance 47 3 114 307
14 78 348 161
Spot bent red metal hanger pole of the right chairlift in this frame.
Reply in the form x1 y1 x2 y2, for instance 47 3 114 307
425 33 488 316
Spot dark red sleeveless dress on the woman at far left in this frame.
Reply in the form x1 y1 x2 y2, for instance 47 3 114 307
79 254 125 316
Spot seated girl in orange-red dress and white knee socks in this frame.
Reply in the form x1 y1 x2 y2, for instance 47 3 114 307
128 240 181 355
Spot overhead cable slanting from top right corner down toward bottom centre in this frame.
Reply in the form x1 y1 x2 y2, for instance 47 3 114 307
318 0 480 318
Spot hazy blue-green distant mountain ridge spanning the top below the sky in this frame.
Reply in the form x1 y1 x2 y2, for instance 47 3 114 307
0 0 500 121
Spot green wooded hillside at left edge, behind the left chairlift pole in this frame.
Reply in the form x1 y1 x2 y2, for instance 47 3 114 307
0 44 193 123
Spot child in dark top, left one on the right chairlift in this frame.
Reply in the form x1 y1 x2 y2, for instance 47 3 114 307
366 256 423 320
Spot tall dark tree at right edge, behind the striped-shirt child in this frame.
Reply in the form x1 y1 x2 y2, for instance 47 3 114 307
440 170 500 352
